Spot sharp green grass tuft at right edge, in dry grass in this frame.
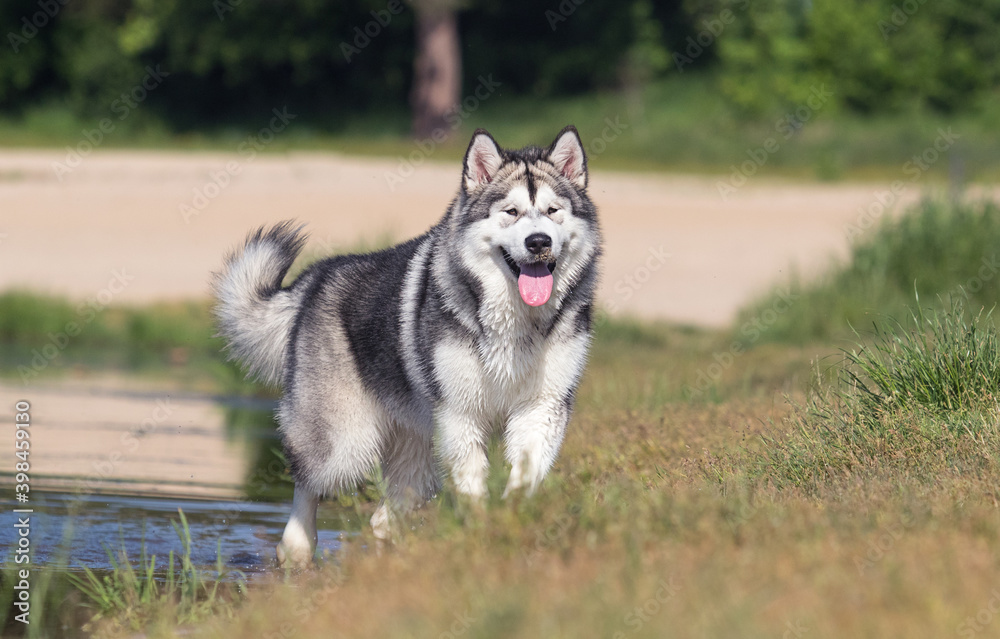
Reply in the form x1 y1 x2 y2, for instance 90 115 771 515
748 303 1000 489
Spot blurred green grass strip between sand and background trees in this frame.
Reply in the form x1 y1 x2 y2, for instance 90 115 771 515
0 76 1000 182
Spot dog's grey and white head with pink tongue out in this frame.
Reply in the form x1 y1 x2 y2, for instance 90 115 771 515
457 126 600 306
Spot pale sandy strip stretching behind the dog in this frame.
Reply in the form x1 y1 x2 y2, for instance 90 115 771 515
0 150 968 325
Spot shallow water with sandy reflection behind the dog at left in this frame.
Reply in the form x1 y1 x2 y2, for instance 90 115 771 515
0 384 361 576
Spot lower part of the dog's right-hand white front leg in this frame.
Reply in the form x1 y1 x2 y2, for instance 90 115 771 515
503 398 569 497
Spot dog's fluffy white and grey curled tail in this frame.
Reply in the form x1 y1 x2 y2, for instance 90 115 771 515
213 221 306 385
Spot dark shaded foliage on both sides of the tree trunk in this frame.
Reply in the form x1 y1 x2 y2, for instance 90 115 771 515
0 0 688 126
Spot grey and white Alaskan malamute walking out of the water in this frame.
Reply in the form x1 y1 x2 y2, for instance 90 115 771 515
215 126 601 565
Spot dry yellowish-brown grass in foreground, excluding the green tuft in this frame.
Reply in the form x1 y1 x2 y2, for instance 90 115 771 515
70 326 984 638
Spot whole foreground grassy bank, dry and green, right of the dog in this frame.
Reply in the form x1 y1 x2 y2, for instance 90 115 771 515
5 196 1000 639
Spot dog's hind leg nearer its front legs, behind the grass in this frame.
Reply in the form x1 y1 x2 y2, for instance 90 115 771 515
372 424 439 540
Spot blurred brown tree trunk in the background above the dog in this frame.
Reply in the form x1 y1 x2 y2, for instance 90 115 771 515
410 0 462 140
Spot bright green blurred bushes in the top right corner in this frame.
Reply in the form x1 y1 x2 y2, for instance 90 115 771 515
697 0 1000 113
